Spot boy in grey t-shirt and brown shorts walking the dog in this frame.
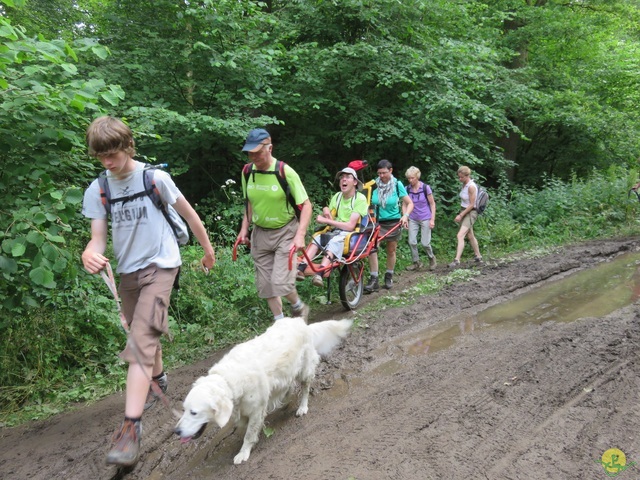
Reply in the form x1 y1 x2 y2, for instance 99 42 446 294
82 116 216 467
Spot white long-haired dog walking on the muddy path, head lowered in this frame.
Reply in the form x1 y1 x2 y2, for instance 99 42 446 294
174 318 353 464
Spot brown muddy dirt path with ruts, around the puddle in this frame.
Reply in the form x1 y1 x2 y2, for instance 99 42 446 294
0 238 640 480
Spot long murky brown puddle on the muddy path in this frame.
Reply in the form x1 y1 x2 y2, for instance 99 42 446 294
397 253 640 355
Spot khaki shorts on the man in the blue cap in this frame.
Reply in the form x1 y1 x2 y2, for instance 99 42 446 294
251 218 298 298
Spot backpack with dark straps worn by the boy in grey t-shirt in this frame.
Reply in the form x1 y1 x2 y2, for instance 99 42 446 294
98 165 189 245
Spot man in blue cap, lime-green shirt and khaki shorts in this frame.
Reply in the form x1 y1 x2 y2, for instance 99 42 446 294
238 128 312 320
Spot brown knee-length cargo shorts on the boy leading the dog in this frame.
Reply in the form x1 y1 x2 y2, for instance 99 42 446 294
118 264 178 367
